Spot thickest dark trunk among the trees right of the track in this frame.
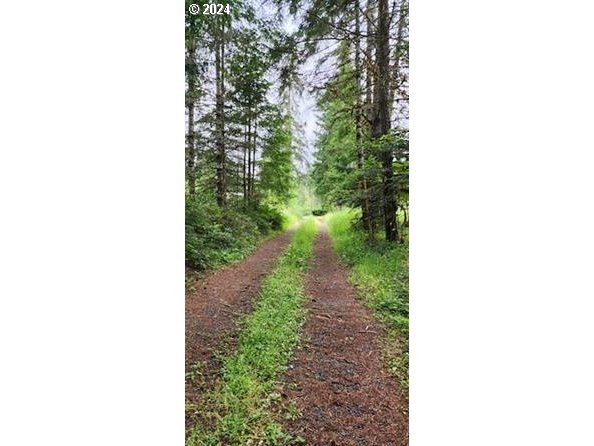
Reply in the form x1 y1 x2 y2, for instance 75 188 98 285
372 0 398 241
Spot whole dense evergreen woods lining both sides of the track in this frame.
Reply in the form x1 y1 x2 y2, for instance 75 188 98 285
186 0 408 268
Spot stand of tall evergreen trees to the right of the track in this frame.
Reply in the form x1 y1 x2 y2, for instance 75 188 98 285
301 0 408 242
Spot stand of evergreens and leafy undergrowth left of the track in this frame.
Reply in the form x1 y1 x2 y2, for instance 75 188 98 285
186 2 299 268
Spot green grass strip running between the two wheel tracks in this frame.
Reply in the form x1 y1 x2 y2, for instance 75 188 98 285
186 219 316 446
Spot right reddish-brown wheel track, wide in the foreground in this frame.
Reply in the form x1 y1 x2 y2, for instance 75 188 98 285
282 222 408 446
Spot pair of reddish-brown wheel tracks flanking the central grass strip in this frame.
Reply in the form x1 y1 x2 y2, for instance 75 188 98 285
186 219 408 446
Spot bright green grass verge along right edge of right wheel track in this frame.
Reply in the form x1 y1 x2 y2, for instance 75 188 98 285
326 210 408 391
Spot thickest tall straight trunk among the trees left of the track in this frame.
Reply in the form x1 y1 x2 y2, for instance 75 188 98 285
215 19 227 206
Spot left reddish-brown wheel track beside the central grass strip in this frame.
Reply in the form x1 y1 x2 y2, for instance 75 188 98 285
186 231 294 426
